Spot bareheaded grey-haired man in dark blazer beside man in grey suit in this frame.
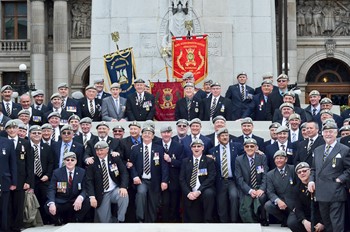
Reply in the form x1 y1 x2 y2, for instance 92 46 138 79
294 122 325 167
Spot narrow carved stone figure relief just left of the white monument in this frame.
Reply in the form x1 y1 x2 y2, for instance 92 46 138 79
70 0 91 39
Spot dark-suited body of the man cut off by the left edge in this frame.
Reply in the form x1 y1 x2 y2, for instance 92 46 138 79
0 132 17 231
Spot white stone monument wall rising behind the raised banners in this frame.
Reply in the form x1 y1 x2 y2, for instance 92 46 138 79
90 0 277 91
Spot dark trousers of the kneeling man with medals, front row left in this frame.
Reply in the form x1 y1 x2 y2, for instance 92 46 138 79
45 198 90 223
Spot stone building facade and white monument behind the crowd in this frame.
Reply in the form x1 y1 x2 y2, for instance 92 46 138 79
0 0 350 104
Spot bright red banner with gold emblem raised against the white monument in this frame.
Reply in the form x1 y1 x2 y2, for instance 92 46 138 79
172 35 208 83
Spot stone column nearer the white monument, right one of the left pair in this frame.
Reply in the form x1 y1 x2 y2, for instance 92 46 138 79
52 0 69 92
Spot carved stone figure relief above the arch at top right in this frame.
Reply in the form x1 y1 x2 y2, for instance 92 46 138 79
297 0 350 36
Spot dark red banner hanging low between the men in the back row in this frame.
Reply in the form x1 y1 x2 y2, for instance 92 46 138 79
151 82 183 121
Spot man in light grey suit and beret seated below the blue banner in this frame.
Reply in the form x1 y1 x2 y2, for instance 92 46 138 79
102 83 127 122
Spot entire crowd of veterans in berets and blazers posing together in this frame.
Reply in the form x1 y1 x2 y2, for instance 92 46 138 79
0 72 350 232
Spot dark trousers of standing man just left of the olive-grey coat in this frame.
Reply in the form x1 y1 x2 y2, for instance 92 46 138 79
10 189 25 231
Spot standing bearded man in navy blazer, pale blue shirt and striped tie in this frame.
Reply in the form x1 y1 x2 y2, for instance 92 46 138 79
209 128 243 223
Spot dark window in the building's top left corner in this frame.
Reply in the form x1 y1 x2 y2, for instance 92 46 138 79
2 1 27 39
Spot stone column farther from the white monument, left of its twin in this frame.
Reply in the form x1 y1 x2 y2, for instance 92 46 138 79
28 0 48 95
